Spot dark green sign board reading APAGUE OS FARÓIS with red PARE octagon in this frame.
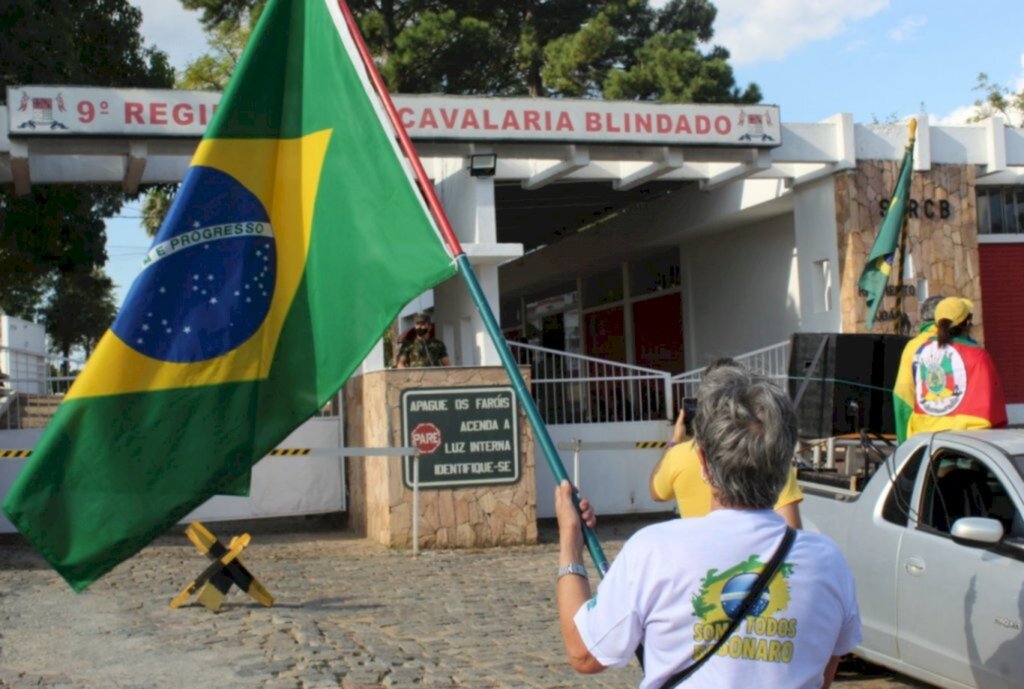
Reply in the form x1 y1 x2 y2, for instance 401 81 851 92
401 386 520 488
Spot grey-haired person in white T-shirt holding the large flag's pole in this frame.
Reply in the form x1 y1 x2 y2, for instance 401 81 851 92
555 367 861 689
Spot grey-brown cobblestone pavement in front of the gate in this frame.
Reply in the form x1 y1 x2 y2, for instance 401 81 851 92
0 515 923 689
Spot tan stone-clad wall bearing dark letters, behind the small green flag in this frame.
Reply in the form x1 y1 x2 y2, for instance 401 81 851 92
836 161 984 342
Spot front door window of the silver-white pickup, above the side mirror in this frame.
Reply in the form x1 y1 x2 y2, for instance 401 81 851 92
921 450 1024 557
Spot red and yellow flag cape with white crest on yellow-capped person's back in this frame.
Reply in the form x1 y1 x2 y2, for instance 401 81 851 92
907 338 1007 437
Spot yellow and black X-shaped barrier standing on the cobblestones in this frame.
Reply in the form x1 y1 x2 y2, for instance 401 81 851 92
171 521 273 612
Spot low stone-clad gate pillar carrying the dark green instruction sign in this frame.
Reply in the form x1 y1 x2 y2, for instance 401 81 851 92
345 367 537 548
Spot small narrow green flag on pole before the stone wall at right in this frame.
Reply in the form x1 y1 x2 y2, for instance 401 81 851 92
857 120 918 329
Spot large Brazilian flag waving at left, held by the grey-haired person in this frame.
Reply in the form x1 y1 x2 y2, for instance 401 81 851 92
3 0 455 590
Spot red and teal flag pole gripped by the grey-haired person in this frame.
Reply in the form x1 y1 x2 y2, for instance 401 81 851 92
338 0 609 576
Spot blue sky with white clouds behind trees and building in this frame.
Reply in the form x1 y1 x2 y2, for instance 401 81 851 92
106 0 1024 303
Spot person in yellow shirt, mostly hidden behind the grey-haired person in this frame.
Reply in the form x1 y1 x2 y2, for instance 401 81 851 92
650 359 804 528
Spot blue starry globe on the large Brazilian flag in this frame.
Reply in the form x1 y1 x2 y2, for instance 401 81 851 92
112 166 278 363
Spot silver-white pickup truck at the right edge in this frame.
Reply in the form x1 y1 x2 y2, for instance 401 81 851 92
801 430 1024 689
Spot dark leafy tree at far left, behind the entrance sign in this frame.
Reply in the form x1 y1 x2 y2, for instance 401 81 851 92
0 0 174 318
